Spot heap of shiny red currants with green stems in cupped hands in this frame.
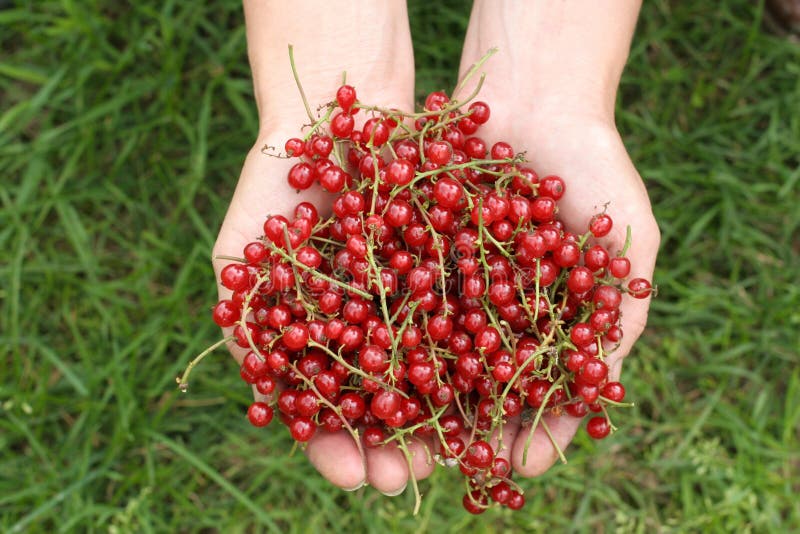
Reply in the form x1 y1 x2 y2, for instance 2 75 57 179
191 80 651 513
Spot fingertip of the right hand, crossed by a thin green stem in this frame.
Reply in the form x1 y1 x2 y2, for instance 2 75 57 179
511 415 581 477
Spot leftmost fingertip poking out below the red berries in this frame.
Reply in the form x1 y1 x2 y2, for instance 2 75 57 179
306 431 367 491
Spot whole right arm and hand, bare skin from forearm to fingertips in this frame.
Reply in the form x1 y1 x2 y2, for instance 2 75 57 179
461 0 660 476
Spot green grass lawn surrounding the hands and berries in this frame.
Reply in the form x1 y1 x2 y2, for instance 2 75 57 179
0 0 800 533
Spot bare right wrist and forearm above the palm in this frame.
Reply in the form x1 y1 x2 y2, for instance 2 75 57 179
461 0 639 124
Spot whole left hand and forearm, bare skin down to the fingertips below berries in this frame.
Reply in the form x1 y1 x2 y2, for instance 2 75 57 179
213 0 433 495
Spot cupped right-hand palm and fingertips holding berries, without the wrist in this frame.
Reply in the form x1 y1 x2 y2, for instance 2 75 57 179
472 104 660 476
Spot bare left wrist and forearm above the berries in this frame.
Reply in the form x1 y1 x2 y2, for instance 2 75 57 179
244 0 414 134
